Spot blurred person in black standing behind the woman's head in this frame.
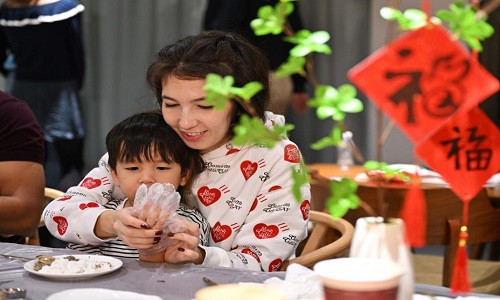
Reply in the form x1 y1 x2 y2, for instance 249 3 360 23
203 0 308 115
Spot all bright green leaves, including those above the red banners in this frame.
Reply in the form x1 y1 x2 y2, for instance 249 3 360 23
205 0 493 217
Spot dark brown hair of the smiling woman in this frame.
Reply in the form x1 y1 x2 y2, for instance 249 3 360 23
146 29 269 123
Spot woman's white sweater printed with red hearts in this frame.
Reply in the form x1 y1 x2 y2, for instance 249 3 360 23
44 114 311 271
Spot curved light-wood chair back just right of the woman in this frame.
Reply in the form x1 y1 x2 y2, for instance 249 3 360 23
280 210 354 271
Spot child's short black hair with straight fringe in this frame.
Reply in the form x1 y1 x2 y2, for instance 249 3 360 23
106 110 204 196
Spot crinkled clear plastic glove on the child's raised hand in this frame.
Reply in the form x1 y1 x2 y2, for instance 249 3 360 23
133 183 190 254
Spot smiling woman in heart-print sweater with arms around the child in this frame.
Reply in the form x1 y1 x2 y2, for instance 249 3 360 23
44 31 310 271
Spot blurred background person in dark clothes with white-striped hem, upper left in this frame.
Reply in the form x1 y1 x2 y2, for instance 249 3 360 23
0 0 85 190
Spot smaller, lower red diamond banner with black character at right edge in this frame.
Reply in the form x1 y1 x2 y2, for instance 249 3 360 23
415 108 500 201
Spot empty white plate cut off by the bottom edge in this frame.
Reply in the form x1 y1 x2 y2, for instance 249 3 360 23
46 288 162 300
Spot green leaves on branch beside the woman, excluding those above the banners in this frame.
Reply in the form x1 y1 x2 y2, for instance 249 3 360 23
205 0 363 217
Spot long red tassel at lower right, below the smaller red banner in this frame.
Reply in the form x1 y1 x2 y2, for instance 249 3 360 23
451 226 471 294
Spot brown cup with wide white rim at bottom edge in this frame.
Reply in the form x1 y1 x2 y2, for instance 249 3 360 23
314 257 404 300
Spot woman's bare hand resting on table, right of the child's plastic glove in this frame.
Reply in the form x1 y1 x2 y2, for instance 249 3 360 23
165 223 205 264
